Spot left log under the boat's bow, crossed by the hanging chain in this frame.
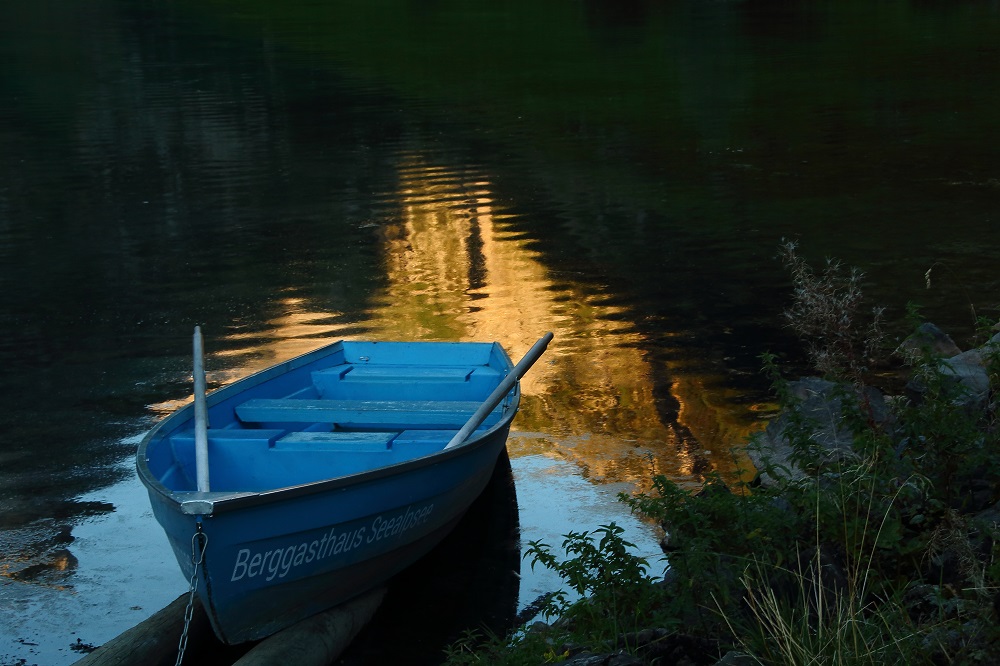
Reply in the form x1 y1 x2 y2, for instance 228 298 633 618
76 594 212 666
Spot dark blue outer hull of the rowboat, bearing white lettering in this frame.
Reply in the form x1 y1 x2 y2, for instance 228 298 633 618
138 343 518 644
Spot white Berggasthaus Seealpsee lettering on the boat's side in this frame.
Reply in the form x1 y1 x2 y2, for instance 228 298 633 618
230 504 434 583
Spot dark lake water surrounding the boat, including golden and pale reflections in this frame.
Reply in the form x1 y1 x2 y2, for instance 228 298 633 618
0 0 1000 663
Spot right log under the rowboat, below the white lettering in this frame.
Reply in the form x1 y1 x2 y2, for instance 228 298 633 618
233 587 385 666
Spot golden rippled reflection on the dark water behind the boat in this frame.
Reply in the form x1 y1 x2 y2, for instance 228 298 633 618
189 157 750 490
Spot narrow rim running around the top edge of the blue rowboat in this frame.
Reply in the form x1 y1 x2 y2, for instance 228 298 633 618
136 340 521 516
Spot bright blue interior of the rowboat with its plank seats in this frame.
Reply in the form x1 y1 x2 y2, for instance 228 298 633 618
147 363 505 492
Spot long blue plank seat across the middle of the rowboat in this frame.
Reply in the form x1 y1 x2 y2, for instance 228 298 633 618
236 398 502 428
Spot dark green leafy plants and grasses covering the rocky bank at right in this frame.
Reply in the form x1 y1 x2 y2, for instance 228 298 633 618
455 243 1000 664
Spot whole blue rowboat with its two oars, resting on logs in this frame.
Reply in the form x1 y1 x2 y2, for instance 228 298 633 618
137 332 552 644
